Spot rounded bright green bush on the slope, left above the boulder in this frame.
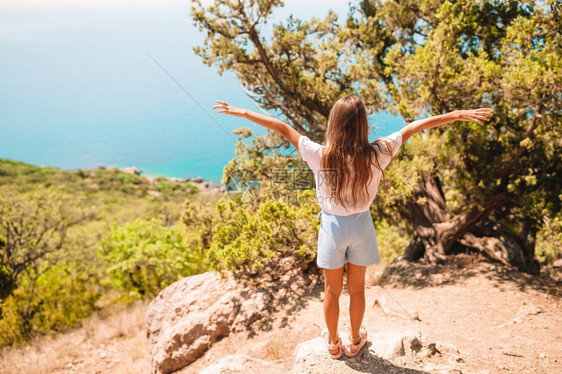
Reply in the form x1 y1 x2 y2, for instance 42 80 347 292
98 219 206 302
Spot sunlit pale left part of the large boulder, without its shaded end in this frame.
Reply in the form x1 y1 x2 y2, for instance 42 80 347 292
146 272 271 373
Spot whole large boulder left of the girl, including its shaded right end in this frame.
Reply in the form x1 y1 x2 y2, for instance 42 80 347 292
146 257 318 373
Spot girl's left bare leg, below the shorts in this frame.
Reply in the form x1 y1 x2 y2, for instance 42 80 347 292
324 266 343 354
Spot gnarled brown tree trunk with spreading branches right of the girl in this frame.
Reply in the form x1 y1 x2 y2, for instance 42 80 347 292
403 177 539 274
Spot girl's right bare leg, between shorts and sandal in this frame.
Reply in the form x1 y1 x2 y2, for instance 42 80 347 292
347 262 367 339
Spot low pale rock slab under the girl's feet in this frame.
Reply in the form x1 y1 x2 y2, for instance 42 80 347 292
191 330 465 374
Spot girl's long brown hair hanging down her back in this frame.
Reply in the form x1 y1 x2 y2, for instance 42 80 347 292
321 96 392 210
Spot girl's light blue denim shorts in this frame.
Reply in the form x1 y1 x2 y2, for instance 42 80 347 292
316 210 380 269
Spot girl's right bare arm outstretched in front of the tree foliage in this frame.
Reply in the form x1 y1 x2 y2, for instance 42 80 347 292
400 108 492 144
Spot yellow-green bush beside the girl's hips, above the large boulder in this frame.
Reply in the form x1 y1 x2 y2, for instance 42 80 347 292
183 190 319 278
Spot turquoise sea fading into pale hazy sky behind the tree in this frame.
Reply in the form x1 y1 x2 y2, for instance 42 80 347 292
0 0 403 181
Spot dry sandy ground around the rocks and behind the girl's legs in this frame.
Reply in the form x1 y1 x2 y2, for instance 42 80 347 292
0 256 562 374
